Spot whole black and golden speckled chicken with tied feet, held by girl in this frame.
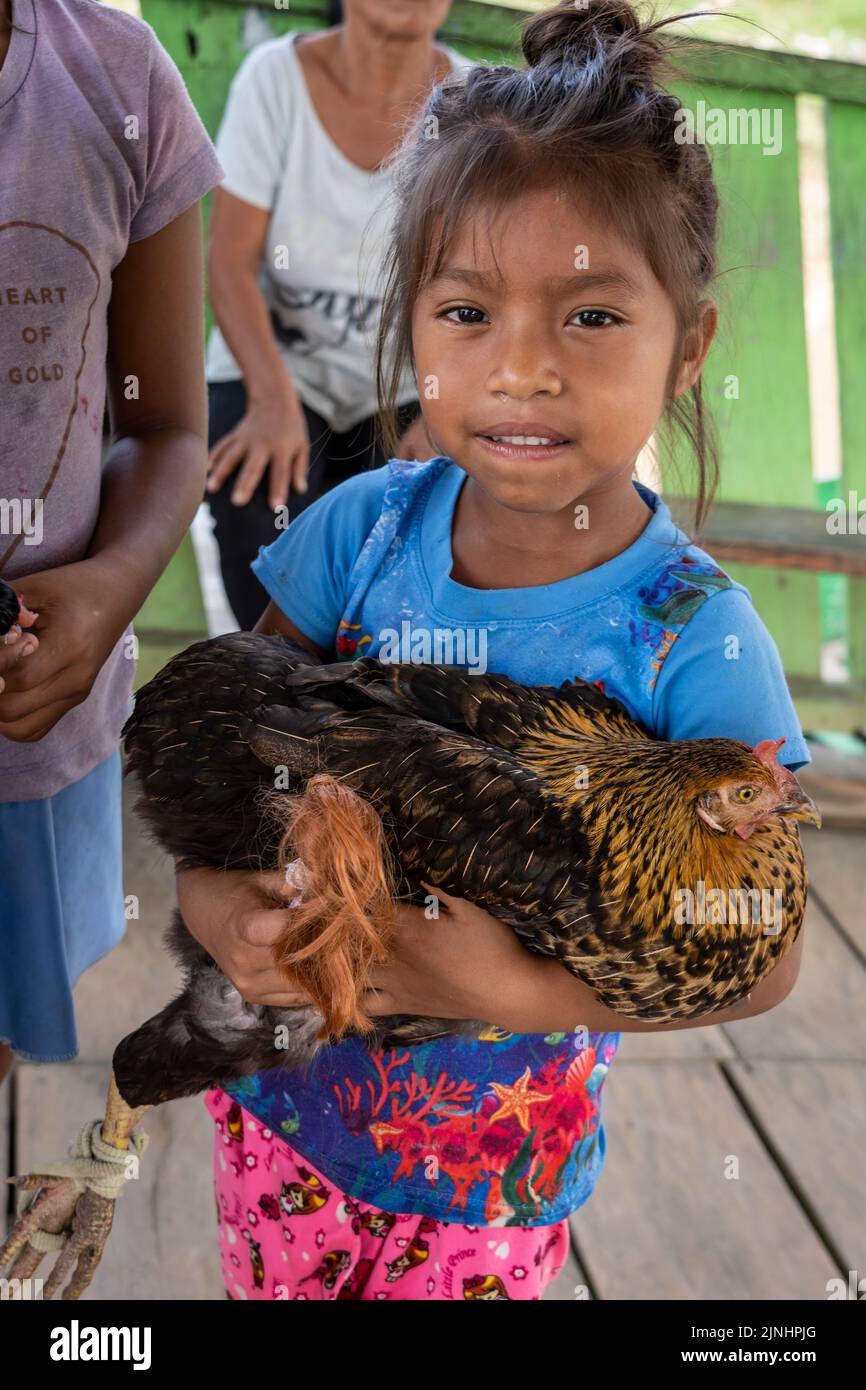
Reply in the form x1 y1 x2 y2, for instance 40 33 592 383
0 632 820 1297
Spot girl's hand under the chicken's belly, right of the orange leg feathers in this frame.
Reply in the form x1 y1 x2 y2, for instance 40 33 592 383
364 884 544 1023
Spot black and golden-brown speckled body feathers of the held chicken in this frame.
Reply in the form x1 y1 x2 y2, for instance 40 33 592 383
125 632 806 1024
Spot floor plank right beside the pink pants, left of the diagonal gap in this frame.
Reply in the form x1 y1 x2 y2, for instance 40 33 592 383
571 1062 840 1301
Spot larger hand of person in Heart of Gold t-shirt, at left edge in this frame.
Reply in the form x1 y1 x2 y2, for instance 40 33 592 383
0 557 128 744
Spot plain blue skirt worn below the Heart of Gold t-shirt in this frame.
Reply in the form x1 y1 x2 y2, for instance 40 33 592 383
0 749 126 1062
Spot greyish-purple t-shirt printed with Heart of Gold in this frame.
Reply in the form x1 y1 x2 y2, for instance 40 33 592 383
0 0 222 802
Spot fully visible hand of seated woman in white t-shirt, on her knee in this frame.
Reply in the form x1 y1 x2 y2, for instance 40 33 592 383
207 382 310 509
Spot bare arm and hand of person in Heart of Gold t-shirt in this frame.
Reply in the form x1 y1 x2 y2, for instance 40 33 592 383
0 204 207 742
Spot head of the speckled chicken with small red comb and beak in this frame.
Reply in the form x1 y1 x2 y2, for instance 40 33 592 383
696 738 822 840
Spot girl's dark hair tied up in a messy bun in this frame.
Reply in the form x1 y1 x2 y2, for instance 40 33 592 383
375 0 719 531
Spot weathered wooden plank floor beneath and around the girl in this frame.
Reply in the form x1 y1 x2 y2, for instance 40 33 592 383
0 783 866 1300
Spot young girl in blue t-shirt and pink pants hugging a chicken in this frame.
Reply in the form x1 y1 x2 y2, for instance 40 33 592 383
179 0 809 1300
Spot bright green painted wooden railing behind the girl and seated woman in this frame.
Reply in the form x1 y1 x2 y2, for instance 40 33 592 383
140 0 866 730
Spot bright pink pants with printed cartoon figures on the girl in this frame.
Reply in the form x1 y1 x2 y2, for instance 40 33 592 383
204 1090 569 1301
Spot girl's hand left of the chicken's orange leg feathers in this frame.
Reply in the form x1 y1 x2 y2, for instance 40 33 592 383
177 869 310 1009
